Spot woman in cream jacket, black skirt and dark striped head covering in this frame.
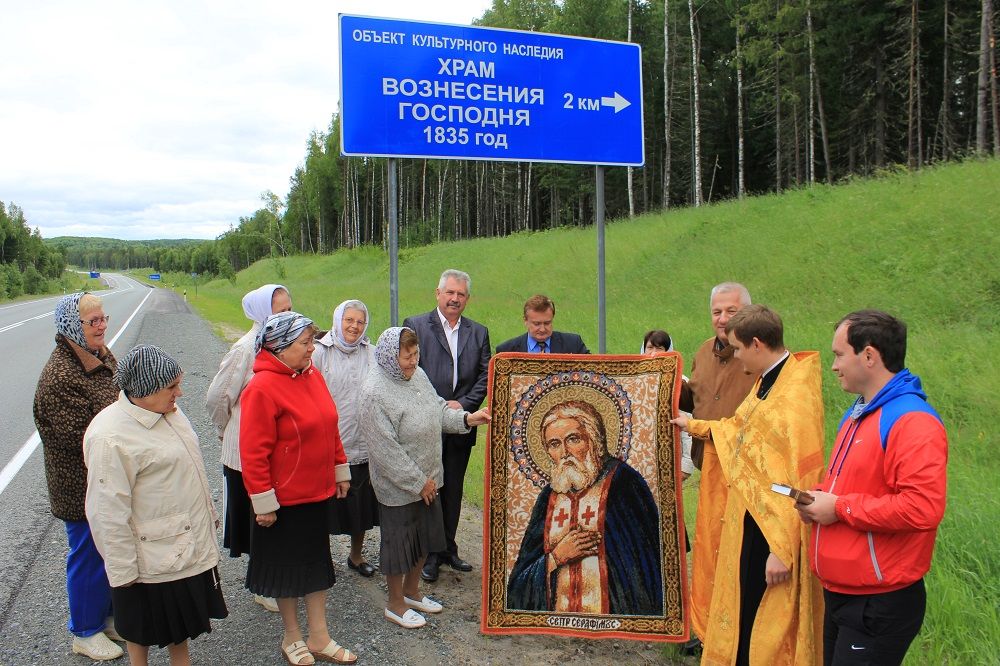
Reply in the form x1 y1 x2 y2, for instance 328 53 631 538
83 345 229 666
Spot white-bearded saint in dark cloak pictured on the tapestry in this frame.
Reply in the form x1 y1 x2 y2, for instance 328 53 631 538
507 400 663 615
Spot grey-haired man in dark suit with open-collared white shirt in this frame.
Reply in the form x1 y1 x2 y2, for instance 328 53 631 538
403 269 490 581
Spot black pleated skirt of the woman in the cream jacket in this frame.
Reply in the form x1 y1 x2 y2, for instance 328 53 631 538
111 568 229 648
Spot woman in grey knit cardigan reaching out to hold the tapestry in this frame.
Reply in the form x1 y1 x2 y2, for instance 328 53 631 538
360 327 490 629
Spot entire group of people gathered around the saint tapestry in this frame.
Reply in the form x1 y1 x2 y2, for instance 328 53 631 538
34 270 947 665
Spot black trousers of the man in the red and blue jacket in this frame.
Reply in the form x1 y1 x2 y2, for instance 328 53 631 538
823 579 927 666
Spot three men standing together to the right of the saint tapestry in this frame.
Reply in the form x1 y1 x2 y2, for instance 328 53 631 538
672 283 948 666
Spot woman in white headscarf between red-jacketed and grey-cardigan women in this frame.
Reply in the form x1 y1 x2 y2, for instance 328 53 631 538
313 300 379 578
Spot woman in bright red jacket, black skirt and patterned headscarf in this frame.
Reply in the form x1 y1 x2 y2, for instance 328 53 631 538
240 312 357 666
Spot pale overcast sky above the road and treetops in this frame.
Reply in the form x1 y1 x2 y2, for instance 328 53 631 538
0 0 491 239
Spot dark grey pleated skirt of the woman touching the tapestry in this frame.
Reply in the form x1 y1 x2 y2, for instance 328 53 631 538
379 497 448 576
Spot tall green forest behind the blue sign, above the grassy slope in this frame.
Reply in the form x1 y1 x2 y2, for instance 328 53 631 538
33 0 1000 276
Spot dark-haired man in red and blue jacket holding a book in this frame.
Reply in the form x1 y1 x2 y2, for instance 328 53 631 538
796 310 948 666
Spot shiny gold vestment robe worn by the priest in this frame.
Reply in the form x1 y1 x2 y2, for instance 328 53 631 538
688 352 823 666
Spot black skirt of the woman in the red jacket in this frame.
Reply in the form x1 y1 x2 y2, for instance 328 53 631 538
246 500 336 599
